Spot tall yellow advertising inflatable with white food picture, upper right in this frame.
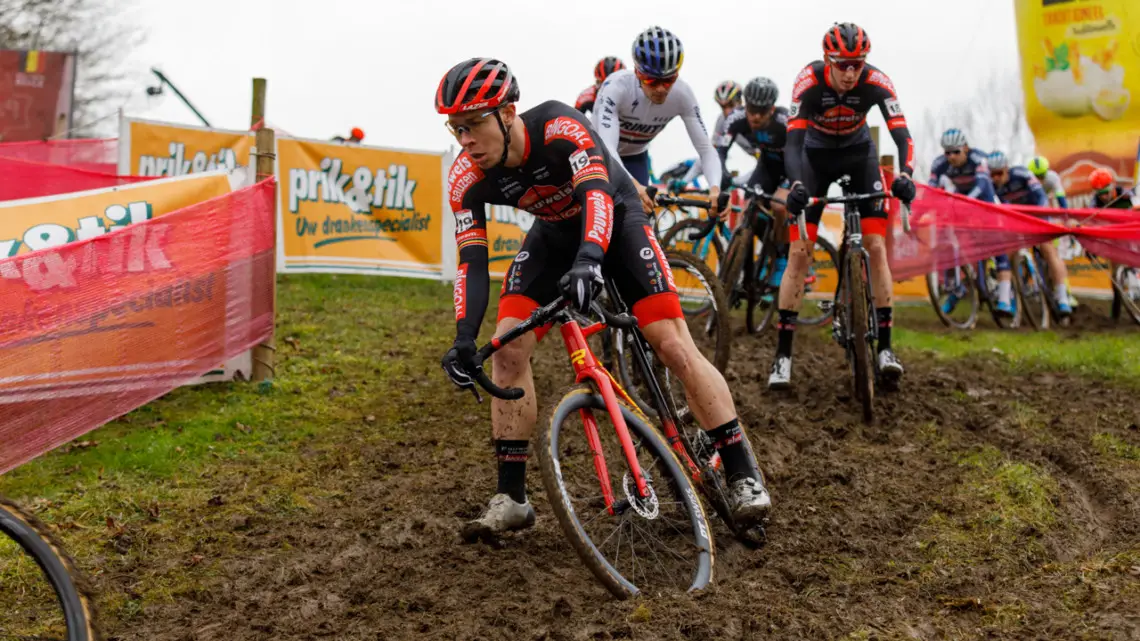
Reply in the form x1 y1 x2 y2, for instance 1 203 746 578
1015 0 1140 195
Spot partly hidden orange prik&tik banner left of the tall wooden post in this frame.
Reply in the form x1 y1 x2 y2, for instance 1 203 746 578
119 119 253 176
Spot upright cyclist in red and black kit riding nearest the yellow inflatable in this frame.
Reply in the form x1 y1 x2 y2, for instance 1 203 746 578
768 23 915 389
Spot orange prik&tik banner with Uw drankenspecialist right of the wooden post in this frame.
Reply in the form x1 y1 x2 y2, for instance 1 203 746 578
277 138 450 278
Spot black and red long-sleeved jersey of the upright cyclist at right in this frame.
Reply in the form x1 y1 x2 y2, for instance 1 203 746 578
784 60 914 181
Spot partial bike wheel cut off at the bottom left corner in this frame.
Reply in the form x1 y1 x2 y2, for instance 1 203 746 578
0 497 100 641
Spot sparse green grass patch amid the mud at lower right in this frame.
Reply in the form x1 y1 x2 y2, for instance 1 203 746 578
919 446 1059 566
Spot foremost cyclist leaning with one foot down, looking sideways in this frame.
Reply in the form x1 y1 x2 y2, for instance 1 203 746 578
435 58 771 541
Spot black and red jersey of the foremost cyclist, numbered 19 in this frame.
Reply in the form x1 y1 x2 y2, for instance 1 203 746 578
447 100 644 339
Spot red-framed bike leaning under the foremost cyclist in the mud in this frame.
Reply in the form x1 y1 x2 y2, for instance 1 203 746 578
453 278 764 599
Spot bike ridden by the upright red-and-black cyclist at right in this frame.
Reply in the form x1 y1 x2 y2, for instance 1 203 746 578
796 176 911 423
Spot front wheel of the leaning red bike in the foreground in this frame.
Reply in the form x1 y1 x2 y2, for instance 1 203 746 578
537 386 715 599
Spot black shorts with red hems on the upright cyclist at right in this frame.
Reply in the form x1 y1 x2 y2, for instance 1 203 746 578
788 144 887 242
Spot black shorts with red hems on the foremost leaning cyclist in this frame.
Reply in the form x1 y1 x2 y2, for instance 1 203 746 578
498 205 683 340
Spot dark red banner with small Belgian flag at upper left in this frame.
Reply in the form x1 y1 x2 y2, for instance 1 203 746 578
0 50 75 143
